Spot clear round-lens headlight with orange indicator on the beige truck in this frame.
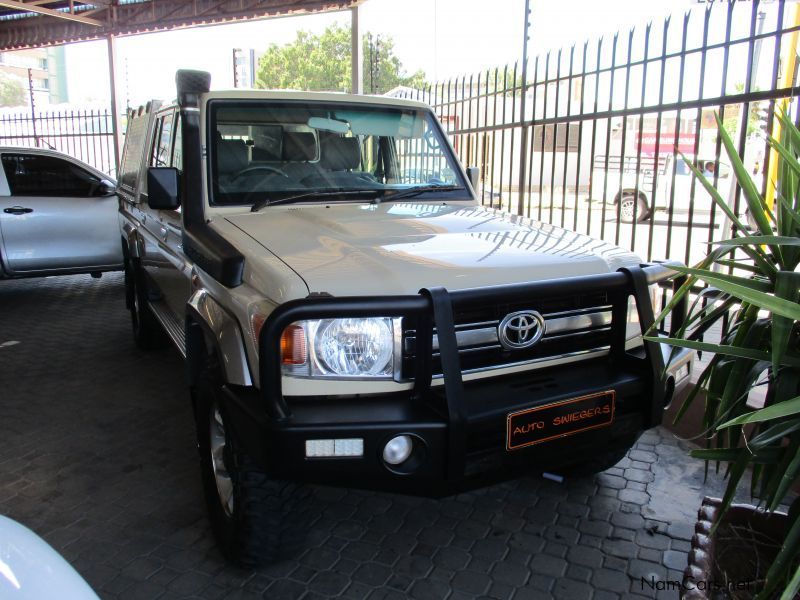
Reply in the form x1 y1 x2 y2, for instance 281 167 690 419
281 317 399 379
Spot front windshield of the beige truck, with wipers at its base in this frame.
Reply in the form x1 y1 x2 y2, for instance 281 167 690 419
209 100 469 205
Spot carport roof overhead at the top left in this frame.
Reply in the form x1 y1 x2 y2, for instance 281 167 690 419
0 0 363 51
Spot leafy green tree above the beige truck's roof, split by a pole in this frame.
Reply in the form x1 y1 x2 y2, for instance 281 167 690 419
256 23 425 94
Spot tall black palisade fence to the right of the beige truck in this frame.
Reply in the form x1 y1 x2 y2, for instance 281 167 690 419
392 2 800 270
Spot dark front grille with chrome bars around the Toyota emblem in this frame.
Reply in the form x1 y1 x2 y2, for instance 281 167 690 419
402 292 611 379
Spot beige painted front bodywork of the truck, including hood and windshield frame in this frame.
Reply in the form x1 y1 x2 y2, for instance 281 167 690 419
123 91 676 396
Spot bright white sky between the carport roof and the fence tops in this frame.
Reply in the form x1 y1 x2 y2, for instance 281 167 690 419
61 0 697 107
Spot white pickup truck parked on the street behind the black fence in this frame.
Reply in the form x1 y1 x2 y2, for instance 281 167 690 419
592 155 731 223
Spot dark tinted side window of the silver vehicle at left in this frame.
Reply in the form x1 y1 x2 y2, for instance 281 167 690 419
2 154 100 197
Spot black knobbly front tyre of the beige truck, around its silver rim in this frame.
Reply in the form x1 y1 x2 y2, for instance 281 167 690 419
192 357 302 567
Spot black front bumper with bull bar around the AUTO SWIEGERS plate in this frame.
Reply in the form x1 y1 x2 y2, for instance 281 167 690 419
225 265 692 496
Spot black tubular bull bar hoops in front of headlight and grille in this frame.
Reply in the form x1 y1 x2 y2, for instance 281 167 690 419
259 263 687 478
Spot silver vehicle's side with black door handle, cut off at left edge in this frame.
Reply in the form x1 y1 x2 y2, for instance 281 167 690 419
0 149 122 274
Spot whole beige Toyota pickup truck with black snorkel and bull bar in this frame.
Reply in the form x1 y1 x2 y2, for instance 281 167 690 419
119 71 692 564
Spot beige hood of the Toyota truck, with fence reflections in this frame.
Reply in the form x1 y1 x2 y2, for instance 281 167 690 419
227 202 640 296
